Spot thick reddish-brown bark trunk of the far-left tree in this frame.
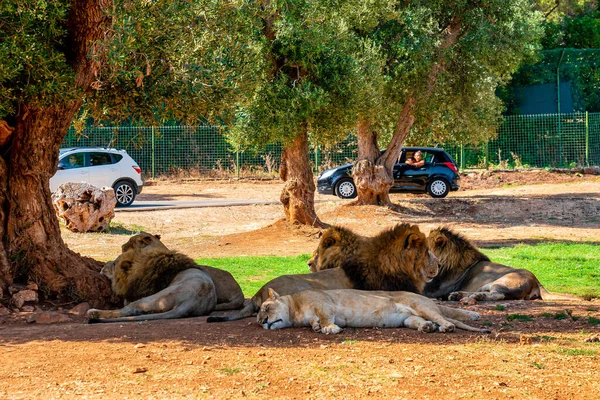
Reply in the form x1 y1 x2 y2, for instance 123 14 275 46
0 0 112 307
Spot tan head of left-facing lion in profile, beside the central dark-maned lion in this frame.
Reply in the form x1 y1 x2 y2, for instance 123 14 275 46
308 226 363 272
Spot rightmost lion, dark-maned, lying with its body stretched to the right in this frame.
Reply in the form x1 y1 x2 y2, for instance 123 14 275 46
424 227 579 302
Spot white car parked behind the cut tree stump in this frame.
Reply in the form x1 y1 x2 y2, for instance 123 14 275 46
50 147 144 207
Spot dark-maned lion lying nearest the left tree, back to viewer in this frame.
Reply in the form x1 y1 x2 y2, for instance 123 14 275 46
87 248 217 323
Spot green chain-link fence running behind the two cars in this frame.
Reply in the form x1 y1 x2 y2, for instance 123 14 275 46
62 113 600 178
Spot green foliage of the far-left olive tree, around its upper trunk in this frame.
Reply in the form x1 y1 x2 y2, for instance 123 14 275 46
0 0 263 122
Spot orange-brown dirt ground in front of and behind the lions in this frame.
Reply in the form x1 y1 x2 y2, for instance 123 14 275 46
0 171 600 399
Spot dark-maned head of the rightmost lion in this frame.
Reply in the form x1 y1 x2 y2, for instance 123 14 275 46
427 227 490 270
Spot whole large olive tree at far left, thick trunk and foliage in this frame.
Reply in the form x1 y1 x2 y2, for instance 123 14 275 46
0 0 262 305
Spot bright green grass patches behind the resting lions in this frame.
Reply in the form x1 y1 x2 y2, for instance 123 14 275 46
197 241 600 297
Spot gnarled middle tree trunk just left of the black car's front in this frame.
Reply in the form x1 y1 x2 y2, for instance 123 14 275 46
279 127 327 228
